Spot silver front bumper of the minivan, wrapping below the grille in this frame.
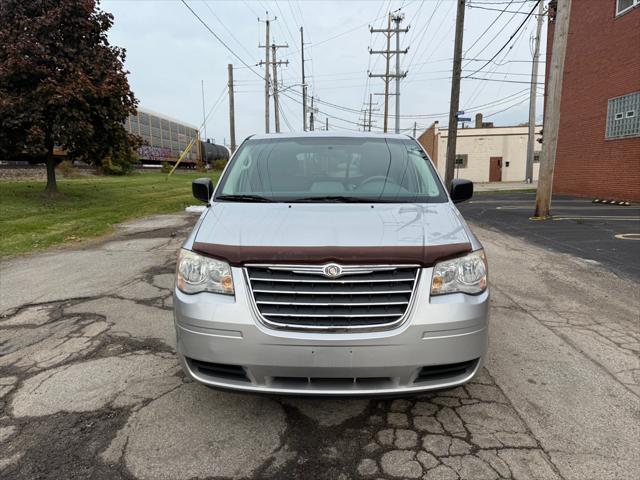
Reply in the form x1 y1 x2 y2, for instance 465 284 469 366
174 268 489 395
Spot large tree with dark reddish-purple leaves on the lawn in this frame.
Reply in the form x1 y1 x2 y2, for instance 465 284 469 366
0 0 137 194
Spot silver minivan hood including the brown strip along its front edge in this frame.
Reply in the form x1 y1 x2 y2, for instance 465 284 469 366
193 202 471 266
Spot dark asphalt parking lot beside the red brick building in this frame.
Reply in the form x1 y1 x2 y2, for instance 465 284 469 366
459 192 640 280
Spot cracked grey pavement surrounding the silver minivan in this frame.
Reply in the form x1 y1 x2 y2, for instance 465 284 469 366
0 214 640 480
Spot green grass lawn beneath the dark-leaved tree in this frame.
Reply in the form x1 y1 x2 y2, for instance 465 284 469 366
0 172 219 257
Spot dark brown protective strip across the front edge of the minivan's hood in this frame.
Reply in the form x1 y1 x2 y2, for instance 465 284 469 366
193 242 471 267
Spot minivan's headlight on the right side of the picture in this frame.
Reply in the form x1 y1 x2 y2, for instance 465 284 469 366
431 250 487 295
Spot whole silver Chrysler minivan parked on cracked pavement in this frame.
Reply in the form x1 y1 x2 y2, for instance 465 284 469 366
173 132 489 395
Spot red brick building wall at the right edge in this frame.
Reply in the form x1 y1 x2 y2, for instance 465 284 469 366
547 0 640 201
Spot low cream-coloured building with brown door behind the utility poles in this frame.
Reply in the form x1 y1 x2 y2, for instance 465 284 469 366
418 114 542 182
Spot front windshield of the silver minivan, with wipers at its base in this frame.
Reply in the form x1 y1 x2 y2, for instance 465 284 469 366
215 137 447 203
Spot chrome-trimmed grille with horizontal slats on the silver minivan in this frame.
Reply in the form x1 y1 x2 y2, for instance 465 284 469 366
245 265 419 331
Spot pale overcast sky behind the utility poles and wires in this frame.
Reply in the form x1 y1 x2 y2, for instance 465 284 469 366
101 0 546 143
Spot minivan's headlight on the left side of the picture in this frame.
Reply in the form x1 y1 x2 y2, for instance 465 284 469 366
176 249 234 295
